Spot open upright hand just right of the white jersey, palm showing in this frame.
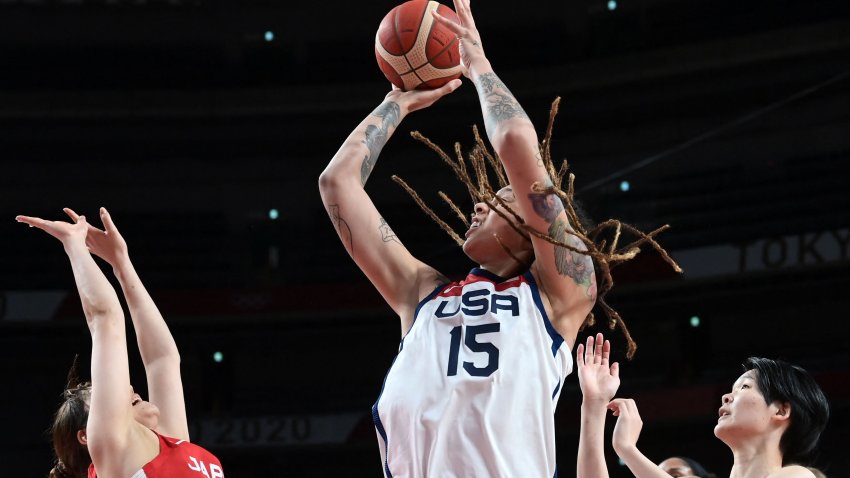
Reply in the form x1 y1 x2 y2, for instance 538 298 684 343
576 333 620 404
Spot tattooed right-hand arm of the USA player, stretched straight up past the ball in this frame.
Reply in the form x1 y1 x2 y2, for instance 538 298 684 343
434 0 596 341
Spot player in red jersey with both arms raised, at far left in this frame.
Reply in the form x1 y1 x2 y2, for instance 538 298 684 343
16 208 224 478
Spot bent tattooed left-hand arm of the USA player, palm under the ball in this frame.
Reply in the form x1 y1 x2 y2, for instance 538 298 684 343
319 80 460 333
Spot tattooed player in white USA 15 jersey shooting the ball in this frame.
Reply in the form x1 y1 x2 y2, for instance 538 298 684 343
319 0 676 477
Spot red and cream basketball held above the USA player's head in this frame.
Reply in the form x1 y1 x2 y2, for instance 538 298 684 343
375 0 461 91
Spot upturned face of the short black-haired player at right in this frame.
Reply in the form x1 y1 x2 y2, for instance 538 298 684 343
714 370 779 446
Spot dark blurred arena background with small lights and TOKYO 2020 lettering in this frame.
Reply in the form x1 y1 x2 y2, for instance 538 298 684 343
0 0 850 478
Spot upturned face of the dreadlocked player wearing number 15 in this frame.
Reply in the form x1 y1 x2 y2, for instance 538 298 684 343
463 186 531 264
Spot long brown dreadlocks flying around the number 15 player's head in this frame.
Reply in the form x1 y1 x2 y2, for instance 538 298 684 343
392 98 682 359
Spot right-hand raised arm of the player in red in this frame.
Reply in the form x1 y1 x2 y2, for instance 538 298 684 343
65 208 189 441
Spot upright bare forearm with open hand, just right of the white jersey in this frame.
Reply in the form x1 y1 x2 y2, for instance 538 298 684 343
576 334 620 478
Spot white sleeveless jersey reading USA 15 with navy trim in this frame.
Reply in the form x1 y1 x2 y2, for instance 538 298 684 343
372 269 572 478
